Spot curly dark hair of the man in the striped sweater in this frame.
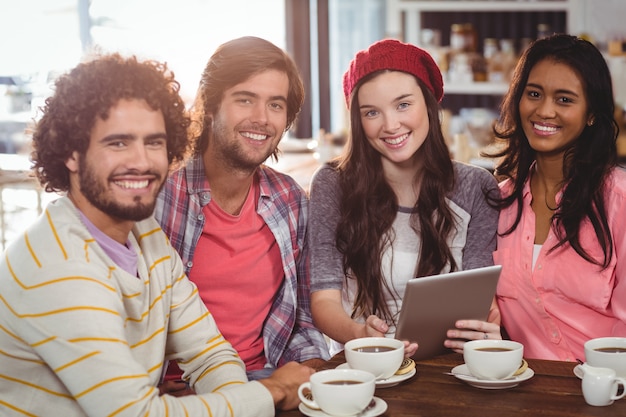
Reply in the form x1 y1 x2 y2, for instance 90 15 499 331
31 54 190 192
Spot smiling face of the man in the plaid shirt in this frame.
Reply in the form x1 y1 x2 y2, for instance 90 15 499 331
208 70 289 171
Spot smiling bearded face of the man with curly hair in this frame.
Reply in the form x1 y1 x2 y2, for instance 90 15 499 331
66 100 169 233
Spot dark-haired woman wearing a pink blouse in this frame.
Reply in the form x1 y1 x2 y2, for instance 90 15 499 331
492 35 626 361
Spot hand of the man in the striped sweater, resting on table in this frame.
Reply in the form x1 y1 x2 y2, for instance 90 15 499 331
259 362 315 410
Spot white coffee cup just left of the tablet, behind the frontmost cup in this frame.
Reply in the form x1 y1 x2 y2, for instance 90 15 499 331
344 337 404 379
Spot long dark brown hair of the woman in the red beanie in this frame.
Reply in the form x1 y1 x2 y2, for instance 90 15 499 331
333 71 457 322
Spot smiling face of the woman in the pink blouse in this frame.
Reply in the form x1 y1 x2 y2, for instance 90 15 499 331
519 59 593 155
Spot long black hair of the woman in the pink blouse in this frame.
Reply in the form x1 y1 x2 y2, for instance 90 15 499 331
490 34 619 268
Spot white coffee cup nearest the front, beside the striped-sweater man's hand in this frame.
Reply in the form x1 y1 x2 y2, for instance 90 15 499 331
298 369 376 416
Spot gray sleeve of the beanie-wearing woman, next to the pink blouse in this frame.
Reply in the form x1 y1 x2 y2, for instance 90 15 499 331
452 162 499 269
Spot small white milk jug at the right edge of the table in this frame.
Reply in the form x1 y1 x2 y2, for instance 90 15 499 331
576 363 626 407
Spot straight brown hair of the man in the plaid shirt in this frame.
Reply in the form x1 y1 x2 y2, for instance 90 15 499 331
191 36 304 158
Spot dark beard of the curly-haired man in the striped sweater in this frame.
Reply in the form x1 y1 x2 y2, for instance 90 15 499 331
79 157 164 222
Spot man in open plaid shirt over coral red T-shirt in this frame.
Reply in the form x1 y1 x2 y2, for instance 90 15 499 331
155 37 329 392
